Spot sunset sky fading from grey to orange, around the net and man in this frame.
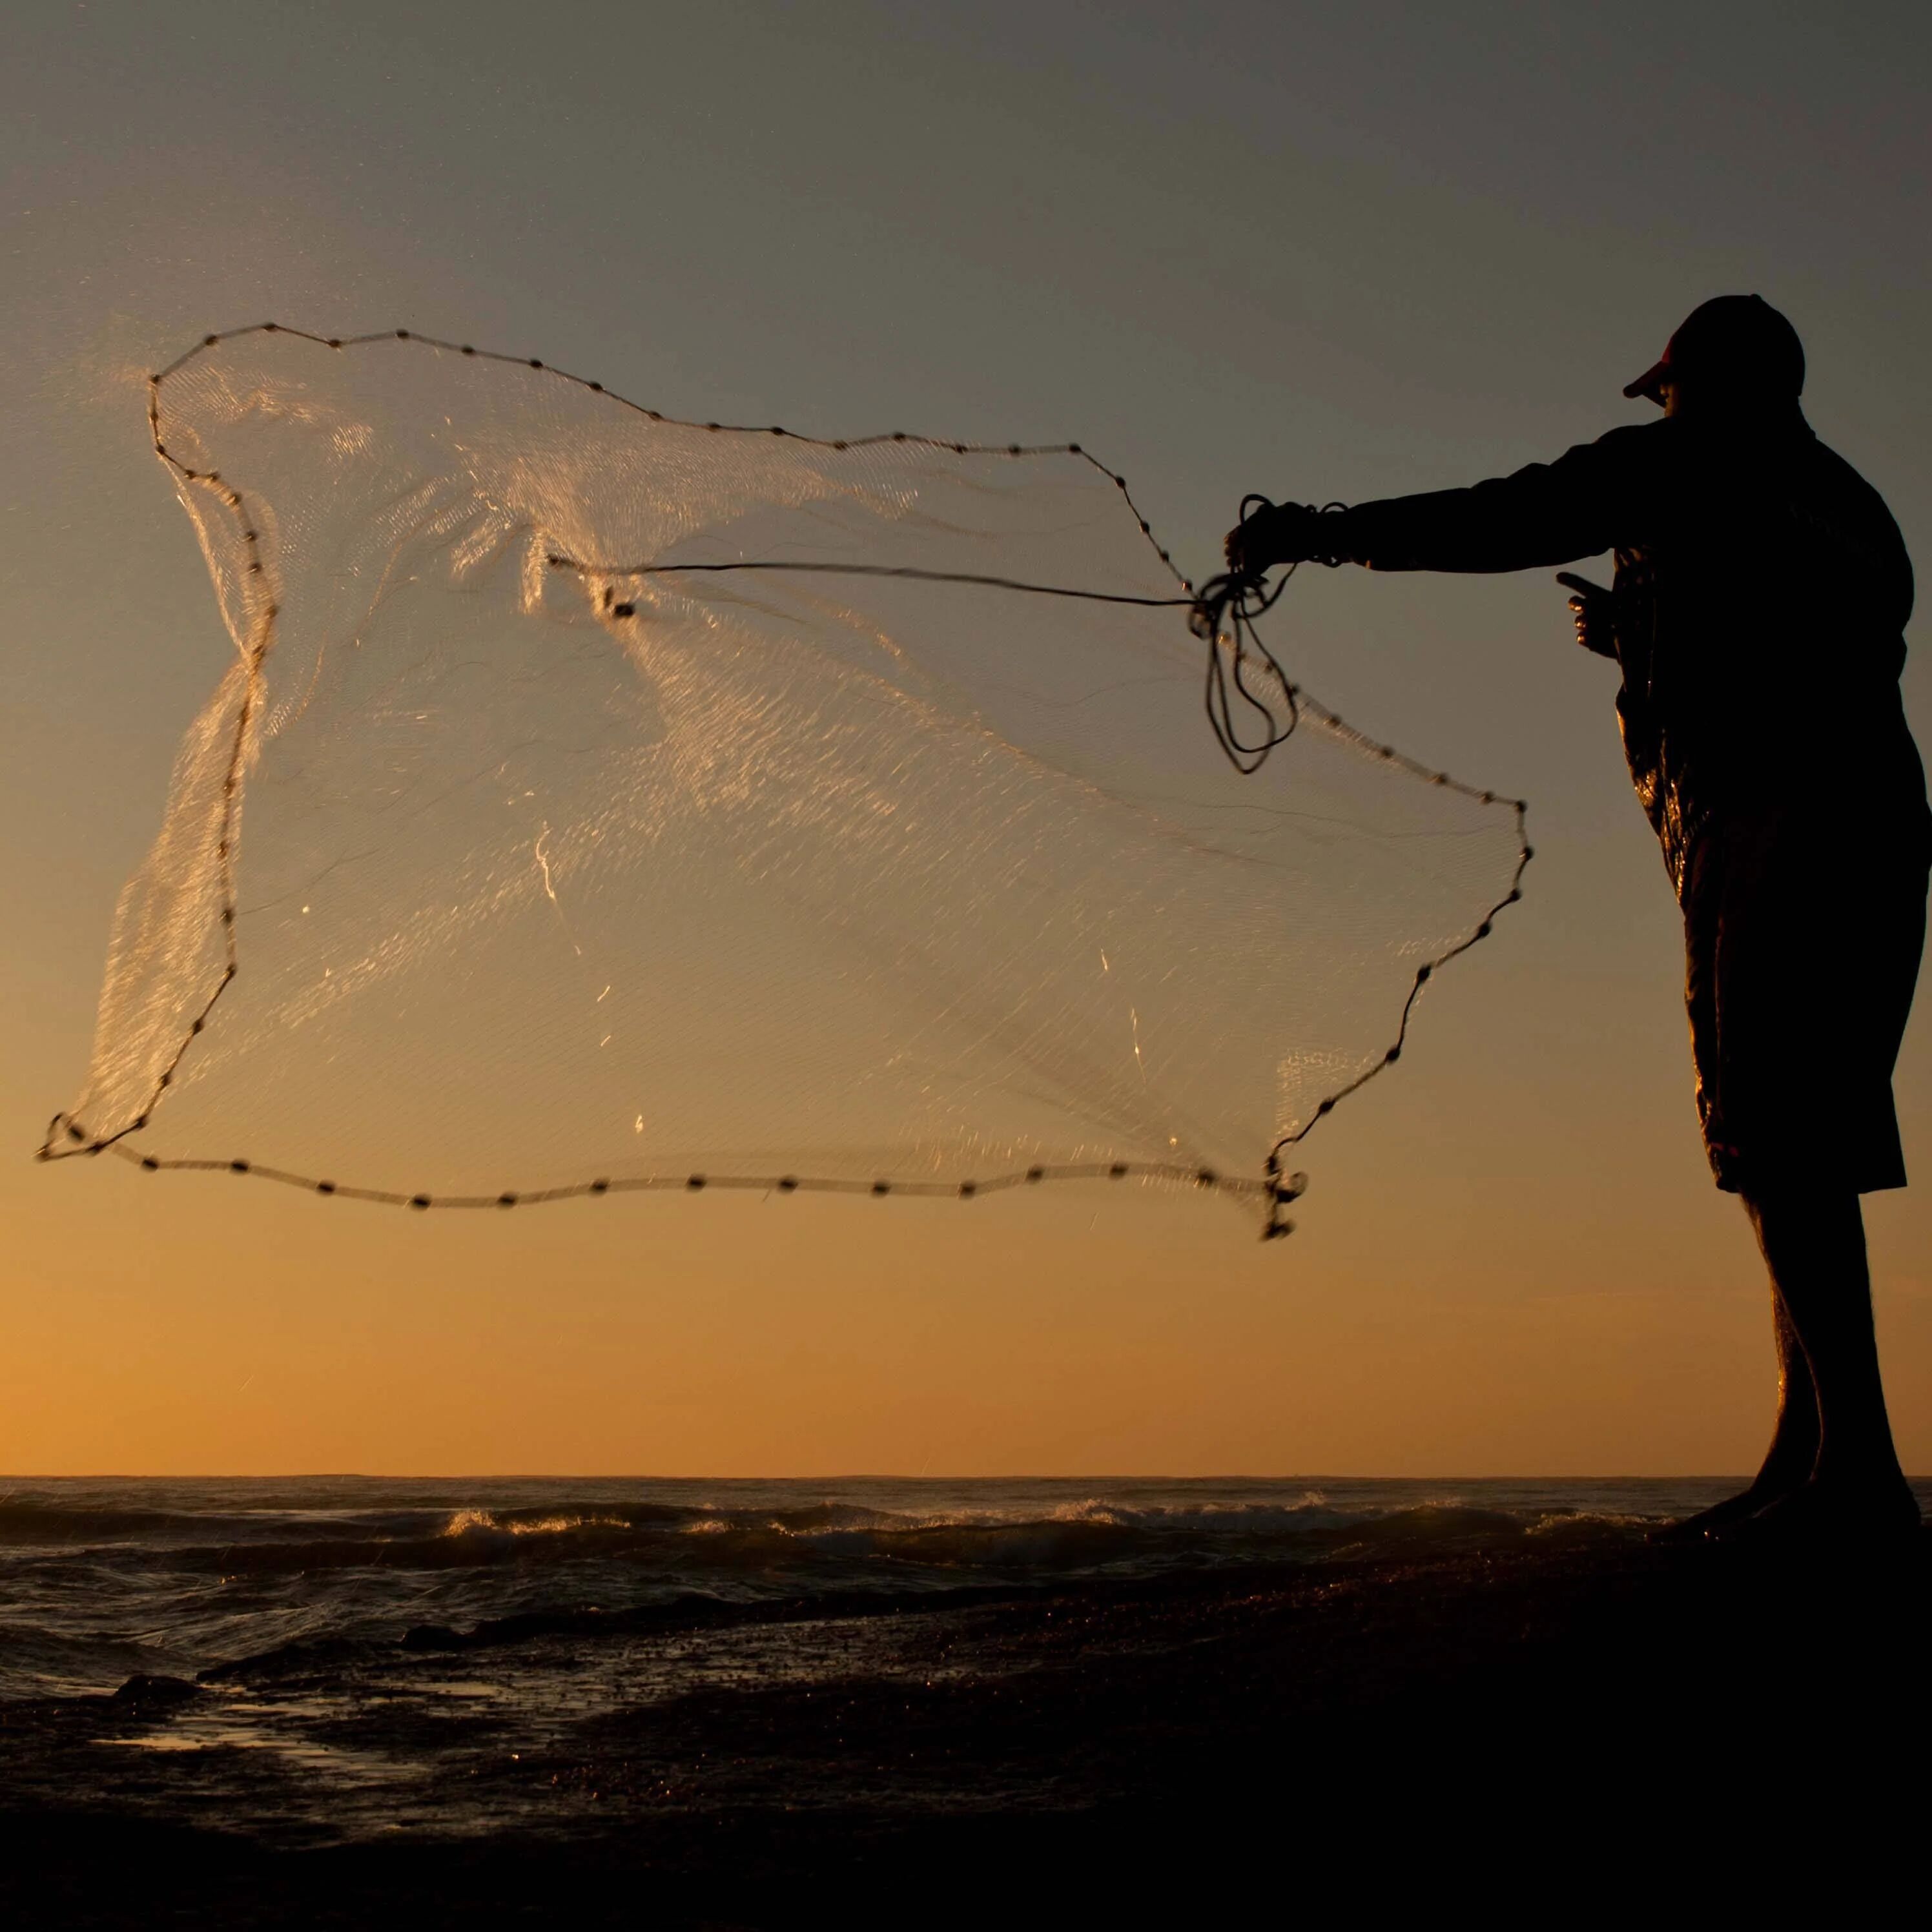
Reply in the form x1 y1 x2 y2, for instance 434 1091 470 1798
0 0 1932 1474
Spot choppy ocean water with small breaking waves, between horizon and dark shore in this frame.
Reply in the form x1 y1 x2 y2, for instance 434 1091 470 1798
0 1476 1762 1698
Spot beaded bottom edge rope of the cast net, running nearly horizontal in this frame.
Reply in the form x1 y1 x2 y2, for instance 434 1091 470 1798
37 1115 1308 1211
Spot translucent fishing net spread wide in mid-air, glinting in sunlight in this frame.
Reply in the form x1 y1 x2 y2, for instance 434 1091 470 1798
43 327 1526 1231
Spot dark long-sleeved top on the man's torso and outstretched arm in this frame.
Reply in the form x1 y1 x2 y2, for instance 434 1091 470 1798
1324 407 1932 889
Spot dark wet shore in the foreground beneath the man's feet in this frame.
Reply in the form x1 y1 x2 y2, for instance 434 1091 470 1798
0 1534 1932 1926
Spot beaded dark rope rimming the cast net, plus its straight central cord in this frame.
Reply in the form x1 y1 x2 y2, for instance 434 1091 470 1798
35 323 1536 1240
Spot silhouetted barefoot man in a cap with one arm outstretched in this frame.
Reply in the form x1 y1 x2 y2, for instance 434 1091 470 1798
1227 296 1932 1538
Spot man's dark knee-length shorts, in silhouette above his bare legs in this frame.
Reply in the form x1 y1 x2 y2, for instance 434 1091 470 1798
1681 808 1928 1194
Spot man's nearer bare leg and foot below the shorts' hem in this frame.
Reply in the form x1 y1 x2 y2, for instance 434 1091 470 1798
1745 1190 1918 1530
